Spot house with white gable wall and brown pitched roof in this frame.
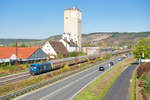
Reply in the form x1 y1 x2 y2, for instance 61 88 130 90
42 41 68 58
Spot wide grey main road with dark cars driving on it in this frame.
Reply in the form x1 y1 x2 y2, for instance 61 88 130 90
15 57 127 100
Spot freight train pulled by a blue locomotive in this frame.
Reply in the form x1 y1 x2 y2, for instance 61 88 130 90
29 50 131 75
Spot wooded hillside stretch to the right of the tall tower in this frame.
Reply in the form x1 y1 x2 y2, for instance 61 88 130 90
83 32 150 46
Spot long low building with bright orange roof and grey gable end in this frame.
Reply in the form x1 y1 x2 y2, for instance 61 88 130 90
0 47 48 62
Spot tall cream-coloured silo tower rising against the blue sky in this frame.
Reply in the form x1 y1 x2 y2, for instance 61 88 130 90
64 7 82 51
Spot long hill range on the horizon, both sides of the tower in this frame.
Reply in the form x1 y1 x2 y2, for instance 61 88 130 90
0 32 150 46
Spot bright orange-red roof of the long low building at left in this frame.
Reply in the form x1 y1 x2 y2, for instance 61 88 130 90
0 47 39 59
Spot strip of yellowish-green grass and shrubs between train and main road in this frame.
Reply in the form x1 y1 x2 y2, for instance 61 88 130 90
0 56 108 96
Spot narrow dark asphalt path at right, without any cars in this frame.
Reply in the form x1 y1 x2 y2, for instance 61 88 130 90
103 61 138 100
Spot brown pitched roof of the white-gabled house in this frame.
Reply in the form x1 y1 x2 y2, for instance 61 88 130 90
49 41 68 55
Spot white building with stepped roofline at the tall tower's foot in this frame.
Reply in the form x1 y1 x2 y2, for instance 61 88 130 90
59 33 79 52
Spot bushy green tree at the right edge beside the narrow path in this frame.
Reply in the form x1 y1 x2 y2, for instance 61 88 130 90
133 38 150 59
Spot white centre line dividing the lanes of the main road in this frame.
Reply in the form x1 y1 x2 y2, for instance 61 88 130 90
40 70 97 100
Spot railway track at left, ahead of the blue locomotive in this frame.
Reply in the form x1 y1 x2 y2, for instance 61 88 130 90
0 72 31 86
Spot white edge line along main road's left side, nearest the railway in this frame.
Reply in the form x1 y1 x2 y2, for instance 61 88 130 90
14 57 119 100
